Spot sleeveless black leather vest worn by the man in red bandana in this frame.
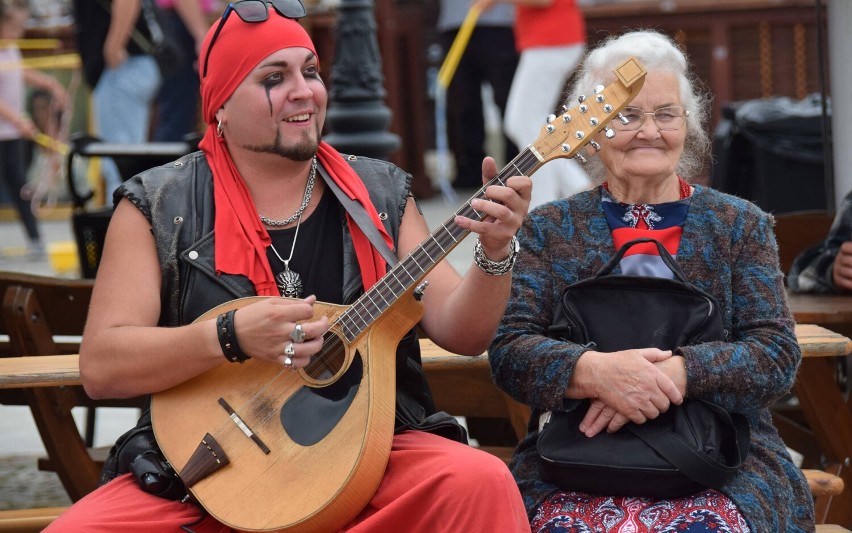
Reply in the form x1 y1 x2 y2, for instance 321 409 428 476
104 152 466 481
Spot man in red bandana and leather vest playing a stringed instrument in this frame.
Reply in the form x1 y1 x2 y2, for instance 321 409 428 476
49 0 532 533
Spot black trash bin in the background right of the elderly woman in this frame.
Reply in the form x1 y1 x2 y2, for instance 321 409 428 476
711 94 830 213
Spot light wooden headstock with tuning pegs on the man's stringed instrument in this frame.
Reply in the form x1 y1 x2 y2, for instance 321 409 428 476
529 57 646 174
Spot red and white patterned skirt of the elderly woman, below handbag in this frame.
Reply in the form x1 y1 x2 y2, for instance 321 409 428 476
531 490 750 533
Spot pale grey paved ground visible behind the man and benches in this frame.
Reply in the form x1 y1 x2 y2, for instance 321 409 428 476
0 190 475 510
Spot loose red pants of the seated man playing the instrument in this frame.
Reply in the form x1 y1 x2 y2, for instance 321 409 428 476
45 431 530 533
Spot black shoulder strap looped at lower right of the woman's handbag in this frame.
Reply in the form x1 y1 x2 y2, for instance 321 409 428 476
626 400 751 489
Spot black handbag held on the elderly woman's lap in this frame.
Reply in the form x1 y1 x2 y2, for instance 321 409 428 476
537 239 750 498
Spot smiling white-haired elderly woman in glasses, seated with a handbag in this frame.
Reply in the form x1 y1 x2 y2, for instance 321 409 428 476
489 31 814 532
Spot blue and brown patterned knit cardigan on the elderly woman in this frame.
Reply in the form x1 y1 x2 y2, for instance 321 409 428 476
489 182 814 533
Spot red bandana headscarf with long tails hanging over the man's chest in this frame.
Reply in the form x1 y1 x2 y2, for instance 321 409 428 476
198 8 393 296
